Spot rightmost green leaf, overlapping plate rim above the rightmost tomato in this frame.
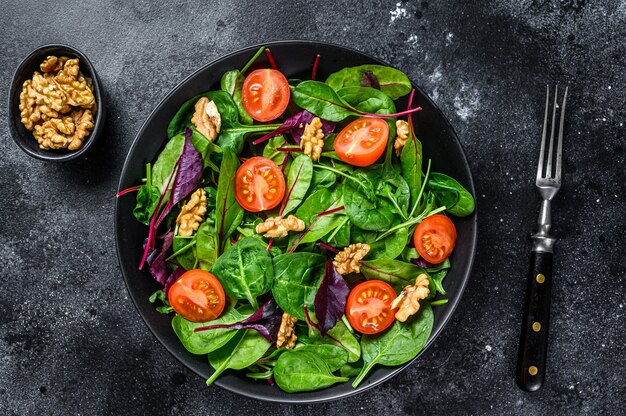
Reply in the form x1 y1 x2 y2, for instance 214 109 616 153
427 172 475 217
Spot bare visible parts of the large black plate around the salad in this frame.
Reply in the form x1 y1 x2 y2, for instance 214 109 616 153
115 41 477 403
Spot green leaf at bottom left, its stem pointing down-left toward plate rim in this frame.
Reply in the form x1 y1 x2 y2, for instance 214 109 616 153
205 329 270 386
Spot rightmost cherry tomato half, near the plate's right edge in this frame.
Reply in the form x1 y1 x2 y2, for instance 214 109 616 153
413 214 456 264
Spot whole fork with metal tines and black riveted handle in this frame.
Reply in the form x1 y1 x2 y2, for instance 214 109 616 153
516 86 568 391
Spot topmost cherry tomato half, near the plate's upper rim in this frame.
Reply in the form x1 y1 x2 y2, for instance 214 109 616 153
241 69 291 122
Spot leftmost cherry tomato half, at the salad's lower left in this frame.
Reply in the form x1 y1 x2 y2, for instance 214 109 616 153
167 269 226 322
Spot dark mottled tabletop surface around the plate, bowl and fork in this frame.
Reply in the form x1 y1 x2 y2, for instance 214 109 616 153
0 0 626 415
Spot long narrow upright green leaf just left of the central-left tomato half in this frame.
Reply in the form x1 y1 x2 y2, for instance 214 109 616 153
215 149 244 256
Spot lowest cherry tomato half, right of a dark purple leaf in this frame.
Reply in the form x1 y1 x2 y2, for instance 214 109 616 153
346 280 396 334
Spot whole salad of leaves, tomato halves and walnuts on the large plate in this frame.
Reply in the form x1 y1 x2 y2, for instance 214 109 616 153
118 48 474 393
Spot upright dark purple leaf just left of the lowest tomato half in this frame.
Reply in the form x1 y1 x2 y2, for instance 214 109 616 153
313 258 350 335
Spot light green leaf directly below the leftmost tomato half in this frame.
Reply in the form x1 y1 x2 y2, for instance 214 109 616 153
172 307 249 354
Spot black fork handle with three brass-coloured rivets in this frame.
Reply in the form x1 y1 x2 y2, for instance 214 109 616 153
516 251 552 391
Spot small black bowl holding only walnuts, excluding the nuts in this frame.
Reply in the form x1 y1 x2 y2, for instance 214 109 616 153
9 45 105 162
